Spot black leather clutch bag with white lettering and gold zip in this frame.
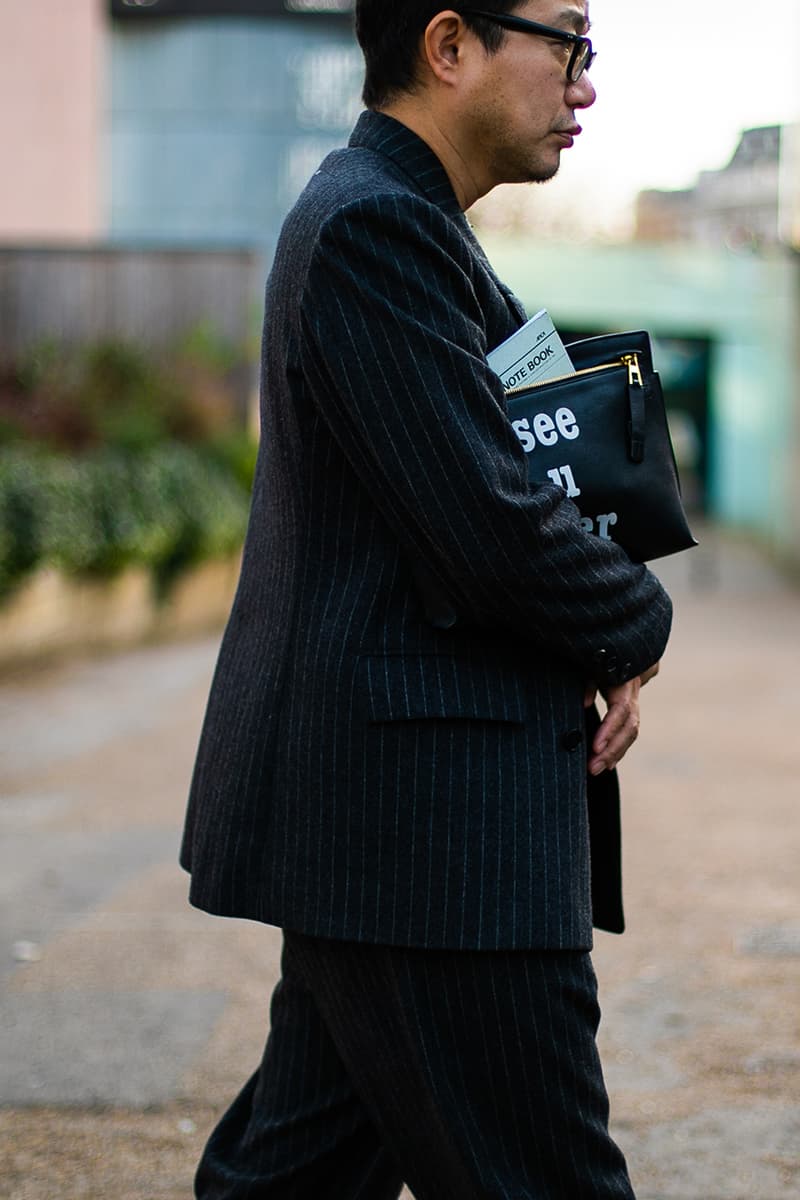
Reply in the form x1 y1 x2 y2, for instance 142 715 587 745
506 331 697 562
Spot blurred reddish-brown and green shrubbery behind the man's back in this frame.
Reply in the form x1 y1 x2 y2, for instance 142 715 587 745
0 325 257 596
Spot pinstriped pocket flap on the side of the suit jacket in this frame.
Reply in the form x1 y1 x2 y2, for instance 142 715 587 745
359 654 525 724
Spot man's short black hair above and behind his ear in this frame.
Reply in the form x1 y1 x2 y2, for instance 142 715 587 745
355 0 519 108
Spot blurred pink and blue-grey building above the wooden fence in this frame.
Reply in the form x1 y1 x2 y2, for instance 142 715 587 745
0 0 361 253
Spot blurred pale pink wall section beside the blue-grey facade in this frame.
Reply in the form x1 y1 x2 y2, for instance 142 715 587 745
0 0 106 244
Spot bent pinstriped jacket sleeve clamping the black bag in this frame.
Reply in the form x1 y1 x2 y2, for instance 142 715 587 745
299 194 672 683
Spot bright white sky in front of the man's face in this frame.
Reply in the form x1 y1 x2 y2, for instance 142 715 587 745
510 0 800 234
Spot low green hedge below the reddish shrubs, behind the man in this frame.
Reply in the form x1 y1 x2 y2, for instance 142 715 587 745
0 434 253 596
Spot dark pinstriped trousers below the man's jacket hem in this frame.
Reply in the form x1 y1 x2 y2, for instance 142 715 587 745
196 932 633 1200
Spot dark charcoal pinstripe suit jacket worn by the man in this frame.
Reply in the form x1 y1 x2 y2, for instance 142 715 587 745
182 113 670 949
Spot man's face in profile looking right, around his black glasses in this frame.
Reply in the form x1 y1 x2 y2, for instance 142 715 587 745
462 0 595 187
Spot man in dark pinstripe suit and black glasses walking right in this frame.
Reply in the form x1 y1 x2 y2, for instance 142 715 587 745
182 0 670 1200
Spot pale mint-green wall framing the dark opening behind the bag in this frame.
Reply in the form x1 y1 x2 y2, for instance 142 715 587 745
481 235 800 559
